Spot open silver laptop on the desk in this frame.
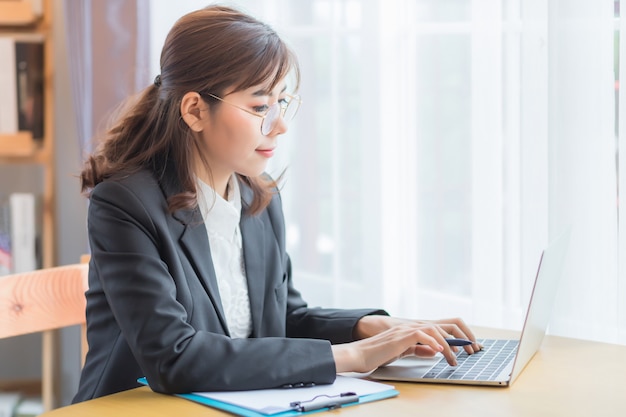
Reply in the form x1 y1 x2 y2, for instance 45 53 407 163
369 229 571 387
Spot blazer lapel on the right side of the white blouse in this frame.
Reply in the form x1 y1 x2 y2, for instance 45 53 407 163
239 181 266 335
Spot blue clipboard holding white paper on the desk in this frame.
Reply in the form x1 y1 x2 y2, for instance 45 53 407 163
138 375 399 417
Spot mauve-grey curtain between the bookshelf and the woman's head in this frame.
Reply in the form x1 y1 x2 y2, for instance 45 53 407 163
63 0 149 155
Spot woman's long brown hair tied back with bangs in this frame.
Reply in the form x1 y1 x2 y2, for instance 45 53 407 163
80 6 300 214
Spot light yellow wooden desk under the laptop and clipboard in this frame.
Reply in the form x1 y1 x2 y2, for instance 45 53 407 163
42 329 626 417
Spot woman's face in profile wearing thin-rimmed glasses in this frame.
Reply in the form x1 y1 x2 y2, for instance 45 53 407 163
201 82 287 187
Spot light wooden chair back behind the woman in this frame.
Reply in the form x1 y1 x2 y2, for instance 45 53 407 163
0 263 88 410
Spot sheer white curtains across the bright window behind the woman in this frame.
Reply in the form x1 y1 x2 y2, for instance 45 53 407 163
151 0 626 343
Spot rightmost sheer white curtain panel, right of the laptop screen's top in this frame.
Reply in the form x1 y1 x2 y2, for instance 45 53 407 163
548 0 626 343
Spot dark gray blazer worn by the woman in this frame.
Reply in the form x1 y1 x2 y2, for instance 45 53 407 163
74 167 386 402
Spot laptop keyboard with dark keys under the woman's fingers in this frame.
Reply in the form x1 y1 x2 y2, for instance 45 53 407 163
424 339 519 381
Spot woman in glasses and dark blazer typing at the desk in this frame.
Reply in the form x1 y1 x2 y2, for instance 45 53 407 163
74 6 480 402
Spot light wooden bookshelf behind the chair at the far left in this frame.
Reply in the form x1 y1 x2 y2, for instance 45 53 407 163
0 0 58 409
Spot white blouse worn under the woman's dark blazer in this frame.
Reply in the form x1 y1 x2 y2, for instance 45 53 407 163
198 176 252 338
